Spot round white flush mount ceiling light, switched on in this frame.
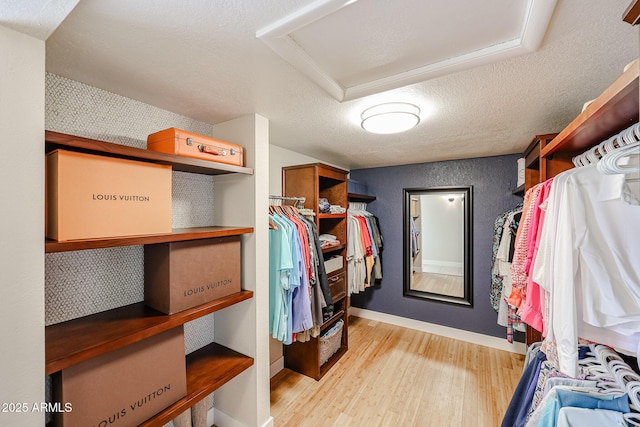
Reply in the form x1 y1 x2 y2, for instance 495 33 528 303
361 102 420 134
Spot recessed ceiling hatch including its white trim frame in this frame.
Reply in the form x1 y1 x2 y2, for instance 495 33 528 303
256 0 556 101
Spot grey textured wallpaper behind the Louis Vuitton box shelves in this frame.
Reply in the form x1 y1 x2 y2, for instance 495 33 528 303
45 73 214 422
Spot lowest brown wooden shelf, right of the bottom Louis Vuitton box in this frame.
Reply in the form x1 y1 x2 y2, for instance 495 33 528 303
140 343 253 427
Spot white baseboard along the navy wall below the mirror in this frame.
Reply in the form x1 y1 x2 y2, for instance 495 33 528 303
349 307 527 354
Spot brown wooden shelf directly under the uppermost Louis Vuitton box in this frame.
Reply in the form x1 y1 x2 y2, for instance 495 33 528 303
44 227 253 253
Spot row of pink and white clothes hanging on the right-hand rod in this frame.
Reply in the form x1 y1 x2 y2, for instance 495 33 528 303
496 131 640 377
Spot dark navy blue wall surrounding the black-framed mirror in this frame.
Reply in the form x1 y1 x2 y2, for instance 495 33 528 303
351 155 522 337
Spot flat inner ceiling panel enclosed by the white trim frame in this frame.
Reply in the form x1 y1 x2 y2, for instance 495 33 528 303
302 0 525 86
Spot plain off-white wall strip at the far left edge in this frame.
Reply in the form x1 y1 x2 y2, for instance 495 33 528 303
0 26 45 427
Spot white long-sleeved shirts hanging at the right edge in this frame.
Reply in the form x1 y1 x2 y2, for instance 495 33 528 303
533 165 640 376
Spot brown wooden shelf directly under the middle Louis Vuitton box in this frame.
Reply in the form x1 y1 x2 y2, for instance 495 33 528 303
45 291 253 375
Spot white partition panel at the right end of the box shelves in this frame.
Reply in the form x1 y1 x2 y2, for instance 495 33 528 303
213 114 273 427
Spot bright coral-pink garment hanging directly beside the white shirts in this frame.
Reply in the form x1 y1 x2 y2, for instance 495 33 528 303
518 178 553 335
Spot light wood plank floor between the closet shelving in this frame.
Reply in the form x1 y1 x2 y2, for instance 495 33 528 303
271 316 524 427
